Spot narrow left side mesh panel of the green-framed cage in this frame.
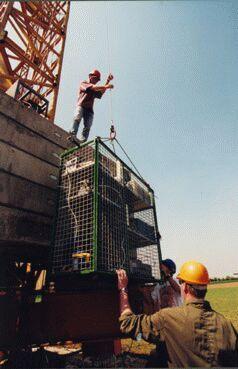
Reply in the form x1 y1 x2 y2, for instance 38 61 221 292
52 145 95 272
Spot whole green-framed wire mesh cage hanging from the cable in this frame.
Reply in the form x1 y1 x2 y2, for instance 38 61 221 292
52 139 160 280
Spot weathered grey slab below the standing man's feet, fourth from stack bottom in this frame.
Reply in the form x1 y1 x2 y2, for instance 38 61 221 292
0 115 64 166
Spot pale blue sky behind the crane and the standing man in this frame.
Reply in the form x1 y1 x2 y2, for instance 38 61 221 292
56 0 238 276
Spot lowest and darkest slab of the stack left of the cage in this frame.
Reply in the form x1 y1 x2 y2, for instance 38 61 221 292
0 206 52 246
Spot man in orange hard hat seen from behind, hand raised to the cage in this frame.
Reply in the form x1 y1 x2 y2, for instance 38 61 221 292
117 260 238 367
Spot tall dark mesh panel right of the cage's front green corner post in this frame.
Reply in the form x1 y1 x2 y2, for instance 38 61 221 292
98 144 129 271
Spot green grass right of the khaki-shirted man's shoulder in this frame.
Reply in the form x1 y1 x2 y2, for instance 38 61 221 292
207 287 238 330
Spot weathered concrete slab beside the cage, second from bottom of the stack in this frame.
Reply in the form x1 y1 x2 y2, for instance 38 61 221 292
0 172 56 216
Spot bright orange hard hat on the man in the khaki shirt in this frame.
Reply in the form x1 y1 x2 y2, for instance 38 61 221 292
177 260 209 285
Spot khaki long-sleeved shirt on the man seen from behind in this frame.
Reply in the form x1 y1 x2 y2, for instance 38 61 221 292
120 301 238 367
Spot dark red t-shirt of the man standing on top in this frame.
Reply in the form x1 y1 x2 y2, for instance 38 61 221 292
78 81 103 111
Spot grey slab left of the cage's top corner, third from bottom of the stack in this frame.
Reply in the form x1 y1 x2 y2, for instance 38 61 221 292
0 142 58 188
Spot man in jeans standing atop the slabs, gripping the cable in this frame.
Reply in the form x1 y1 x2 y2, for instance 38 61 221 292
69 69 113 143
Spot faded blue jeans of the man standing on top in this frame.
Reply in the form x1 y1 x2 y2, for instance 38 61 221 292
70 106 94 142
